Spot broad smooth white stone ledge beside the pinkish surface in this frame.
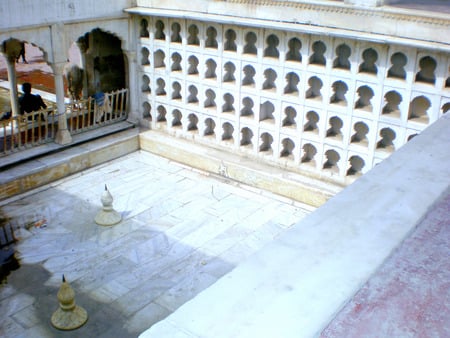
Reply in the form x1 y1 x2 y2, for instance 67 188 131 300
140 114 450 338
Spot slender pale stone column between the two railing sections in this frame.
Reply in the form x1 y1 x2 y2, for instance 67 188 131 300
52 62 72 144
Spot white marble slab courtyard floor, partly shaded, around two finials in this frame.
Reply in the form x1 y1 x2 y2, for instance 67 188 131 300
0 151 311 338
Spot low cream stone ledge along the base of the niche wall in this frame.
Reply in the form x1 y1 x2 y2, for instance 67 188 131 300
139 130 342 207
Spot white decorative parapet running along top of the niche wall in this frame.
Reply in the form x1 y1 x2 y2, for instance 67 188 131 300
131 0 450 51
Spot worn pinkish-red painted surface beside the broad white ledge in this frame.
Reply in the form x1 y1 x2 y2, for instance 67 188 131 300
320 193 450 338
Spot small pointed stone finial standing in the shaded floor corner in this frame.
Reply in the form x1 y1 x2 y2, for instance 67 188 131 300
51 275 88 331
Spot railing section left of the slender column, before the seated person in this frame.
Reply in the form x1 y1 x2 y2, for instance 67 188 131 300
0 107 58 155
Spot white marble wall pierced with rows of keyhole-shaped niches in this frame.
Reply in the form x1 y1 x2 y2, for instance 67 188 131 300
136 16 450 180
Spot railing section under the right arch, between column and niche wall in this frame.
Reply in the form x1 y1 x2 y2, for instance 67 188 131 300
66 89 128 134
